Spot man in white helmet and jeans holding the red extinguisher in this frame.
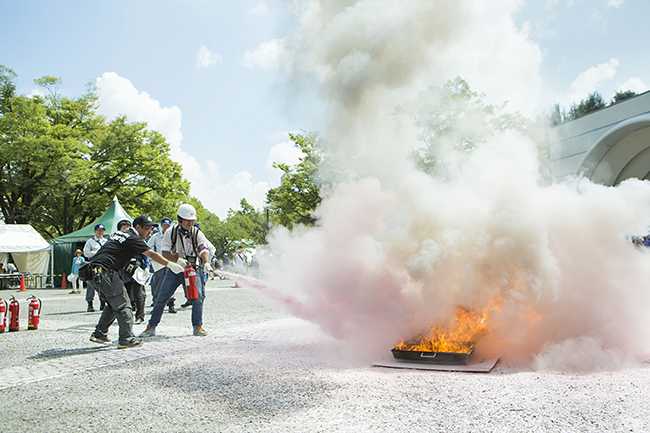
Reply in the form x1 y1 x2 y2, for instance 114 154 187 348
140 204 212 338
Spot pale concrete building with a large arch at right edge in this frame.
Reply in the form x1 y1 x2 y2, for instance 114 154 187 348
548 92 650 185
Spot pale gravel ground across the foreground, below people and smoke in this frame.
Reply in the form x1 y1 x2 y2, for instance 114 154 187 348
0 280 650 432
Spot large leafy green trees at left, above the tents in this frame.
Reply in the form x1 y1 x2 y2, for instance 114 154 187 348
0 67 189 238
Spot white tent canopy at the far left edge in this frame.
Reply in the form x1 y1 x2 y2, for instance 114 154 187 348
0 224 50 274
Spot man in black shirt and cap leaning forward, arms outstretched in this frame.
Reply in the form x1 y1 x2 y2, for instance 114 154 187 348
89 215 183 349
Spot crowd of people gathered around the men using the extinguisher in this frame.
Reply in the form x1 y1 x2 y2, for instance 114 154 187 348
68 204 248 349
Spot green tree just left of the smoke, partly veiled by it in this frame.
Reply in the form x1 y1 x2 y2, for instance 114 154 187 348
266 132 323 229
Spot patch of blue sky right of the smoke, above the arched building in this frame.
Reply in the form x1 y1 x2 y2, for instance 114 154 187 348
514 0 650 106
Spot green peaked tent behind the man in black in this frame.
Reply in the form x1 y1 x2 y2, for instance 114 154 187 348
50 197 133 287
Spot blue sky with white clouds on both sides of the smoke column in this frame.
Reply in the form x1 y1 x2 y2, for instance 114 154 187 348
0 0 650 217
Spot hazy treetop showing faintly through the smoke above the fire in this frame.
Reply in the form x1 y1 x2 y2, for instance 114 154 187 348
408 77 529 174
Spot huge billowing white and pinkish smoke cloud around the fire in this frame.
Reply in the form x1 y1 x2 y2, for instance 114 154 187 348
254 0 650 368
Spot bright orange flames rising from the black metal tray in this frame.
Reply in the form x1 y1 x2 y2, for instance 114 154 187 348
395 296 502 353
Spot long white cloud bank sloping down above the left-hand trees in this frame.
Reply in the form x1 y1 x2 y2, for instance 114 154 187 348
97 72 269 218
